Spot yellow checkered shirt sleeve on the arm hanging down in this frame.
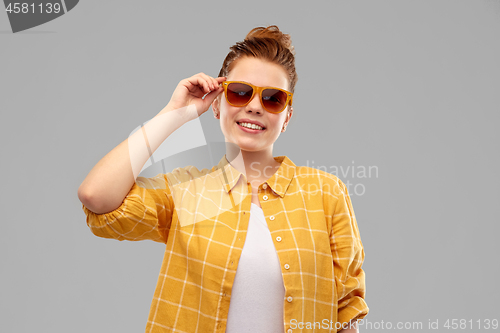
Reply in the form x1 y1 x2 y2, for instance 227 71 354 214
330 180 369 327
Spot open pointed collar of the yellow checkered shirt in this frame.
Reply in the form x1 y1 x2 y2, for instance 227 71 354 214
217 155 296 198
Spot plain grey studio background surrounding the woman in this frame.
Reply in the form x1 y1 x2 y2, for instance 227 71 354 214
0 0 500 332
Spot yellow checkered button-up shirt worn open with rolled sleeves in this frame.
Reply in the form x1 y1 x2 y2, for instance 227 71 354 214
82 155 368 333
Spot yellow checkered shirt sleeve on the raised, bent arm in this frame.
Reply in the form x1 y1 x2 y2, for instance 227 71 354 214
82 174 174 243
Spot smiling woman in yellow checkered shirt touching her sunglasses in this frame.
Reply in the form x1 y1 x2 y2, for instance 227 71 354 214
78 26 368 333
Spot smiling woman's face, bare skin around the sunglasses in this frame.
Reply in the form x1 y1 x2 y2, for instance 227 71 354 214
214 57 291 151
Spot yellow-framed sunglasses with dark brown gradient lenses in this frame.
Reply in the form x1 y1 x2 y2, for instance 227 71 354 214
222 81 293 113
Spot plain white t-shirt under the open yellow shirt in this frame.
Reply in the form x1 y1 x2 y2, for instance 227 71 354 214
226 203 285 333
